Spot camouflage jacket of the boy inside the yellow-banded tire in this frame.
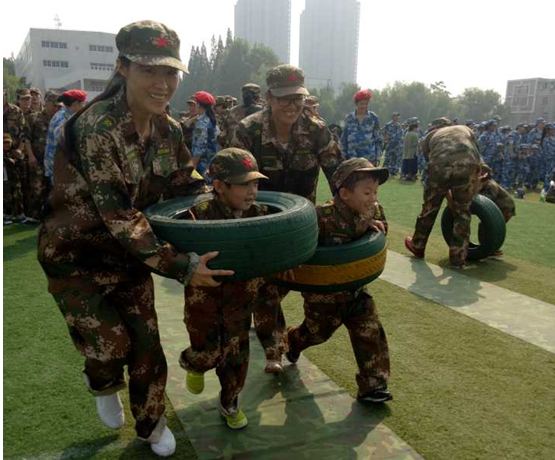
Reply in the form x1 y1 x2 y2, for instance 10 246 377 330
303 195 388 303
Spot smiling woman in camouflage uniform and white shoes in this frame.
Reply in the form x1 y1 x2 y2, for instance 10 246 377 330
38 21 233 456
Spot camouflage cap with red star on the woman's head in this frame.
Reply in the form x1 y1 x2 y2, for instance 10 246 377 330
116 21 189 73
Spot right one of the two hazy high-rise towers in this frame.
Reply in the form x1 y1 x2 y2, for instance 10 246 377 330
299 0 360 90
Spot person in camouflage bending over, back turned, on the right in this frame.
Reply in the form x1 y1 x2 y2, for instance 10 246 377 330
405 118 482 268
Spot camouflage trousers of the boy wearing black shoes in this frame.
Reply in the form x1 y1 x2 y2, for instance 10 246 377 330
288 291 390 396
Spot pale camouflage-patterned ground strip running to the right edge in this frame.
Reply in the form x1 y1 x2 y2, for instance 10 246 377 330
380 251 555 353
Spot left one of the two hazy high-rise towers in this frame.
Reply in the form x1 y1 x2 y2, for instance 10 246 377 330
235 0 291 64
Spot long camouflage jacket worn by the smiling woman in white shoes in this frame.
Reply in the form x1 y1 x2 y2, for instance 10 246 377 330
38 86 205 292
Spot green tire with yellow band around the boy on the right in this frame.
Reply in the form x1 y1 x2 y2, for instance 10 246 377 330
272 232 387 294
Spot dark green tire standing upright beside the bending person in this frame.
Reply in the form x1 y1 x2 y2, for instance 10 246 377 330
441 195 507 260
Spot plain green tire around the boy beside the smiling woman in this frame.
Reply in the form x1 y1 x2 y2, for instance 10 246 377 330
144 192 318 281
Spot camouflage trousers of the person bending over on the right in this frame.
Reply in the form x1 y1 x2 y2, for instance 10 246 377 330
412 161 480 265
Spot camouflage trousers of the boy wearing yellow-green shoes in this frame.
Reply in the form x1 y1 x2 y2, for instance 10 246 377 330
179 282 252 414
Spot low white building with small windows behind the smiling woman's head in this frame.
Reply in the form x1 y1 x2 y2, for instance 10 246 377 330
15 29 118 100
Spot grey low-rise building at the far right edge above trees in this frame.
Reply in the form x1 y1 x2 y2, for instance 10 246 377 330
505 78 555 126
